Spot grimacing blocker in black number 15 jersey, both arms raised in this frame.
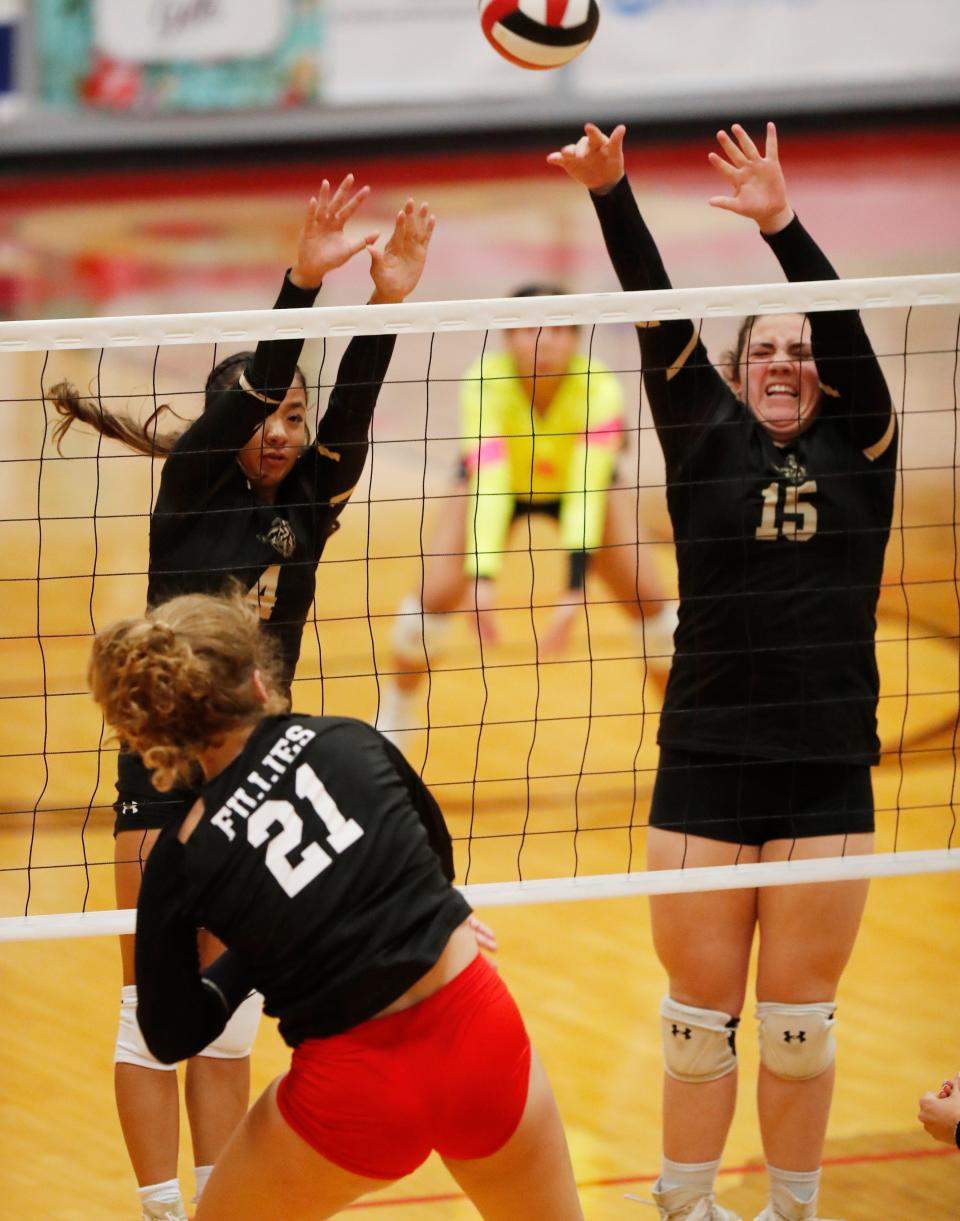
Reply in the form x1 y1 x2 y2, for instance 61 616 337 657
547 123 896 1221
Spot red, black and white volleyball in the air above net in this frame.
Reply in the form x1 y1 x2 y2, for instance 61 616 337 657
480 0 600 68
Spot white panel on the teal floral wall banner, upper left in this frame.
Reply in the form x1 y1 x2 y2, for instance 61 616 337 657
93 0 289 63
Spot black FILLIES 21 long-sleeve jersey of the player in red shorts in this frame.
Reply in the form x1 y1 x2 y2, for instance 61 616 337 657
137 716 470 1062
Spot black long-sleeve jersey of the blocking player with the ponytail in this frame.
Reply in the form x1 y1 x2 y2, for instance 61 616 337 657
148 277 395 683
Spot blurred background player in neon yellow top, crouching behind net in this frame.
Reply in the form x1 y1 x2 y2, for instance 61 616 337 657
377 283 677 746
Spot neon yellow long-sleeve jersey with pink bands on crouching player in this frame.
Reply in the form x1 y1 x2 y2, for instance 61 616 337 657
460 352 624 578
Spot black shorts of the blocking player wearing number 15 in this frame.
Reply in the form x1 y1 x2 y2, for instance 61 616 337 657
650 747 873 845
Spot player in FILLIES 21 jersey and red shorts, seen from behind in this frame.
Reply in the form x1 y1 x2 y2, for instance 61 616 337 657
89 595 583 1221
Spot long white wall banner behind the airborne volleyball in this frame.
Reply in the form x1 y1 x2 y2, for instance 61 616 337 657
322 0 960 113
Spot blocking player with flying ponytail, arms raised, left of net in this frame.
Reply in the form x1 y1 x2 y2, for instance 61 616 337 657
51 176 434 1219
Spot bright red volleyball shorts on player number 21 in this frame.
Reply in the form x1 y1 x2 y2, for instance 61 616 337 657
276 954 530 1179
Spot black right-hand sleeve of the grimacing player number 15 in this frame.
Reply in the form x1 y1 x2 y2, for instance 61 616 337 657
762 216 893 449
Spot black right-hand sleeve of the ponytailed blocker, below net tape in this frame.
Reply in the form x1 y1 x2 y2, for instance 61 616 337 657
303 335 396 510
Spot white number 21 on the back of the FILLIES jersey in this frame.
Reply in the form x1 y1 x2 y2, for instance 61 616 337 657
247 763 363 899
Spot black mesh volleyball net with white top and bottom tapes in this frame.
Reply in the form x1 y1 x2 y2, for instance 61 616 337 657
0 275 960 939
